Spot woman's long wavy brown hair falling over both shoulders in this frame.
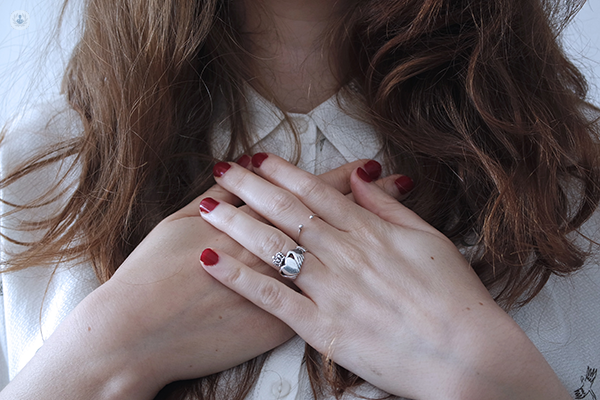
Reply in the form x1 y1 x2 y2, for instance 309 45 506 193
1 0 600 399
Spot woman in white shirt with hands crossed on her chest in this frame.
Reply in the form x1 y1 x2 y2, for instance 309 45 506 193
0 0 600 399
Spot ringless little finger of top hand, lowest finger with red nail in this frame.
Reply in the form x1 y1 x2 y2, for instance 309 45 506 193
200 249 317 332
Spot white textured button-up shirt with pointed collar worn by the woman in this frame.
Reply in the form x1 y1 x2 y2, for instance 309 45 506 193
0 92 600 400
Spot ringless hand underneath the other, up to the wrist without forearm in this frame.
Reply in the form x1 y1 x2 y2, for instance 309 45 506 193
103 157 400 383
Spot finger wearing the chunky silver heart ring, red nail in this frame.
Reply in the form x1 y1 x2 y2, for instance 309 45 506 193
202 199 326 284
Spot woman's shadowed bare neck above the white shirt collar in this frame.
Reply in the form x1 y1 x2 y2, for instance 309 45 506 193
237 0 347 113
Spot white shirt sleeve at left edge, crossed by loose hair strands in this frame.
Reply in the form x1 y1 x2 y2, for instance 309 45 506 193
0 100 98 384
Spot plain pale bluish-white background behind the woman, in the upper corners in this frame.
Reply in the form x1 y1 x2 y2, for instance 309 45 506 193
0 0 600 126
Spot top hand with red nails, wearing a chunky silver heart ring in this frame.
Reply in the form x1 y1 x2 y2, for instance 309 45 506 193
202 153 568 399
